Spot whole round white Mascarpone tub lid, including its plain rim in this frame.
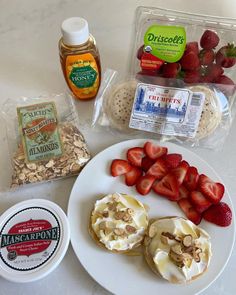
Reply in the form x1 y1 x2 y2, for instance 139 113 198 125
0 199 70 283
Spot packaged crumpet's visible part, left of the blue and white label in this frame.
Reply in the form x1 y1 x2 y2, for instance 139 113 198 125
103 80 137 131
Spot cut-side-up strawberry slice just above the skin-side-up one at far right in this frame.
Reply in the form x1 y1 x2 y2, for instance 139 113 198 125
198 174 225 204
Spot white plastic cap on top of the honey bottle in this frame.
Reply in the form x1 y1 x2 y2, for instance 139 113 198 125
61 17 89 45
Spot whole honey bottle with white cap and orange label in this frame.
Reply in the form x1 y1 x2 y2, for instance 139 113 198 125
59 17 101 100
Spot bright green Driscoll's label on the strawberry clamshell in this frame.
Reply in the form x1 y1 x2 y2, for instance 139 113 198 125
144 25 186 62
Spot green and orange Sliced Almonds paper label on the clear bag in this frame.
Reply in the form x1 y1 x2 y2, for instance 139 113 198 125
17 102 62 162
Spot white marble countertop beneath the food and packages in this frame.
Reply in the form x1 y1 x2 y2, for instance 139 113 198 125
0 0 236 295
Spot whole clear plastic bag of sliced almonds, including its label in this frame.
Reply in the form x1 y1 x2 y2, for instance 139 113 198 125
1 94 91 188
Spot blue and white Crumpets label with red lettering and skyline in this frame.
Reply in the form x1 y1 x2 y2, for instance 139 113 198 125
129 83 205 138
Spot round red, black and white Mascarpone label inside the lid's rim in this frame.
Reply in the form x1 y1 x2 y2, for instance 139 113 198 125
0 207 61 271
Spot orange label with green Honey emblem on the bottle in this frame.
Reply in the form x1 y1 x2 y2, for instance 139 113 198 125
66 53 100 99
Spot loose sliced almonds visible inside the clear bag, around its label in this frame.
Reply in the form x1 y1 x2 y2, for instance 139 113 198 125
11 123 91 187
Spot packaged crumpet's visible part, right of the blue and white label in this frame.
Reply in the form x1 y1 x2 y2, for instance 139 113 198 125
189 85 222 139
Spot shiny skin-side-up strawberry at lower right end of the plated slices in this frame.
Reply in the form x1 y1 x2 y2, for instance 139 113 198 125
203 202 232 226
